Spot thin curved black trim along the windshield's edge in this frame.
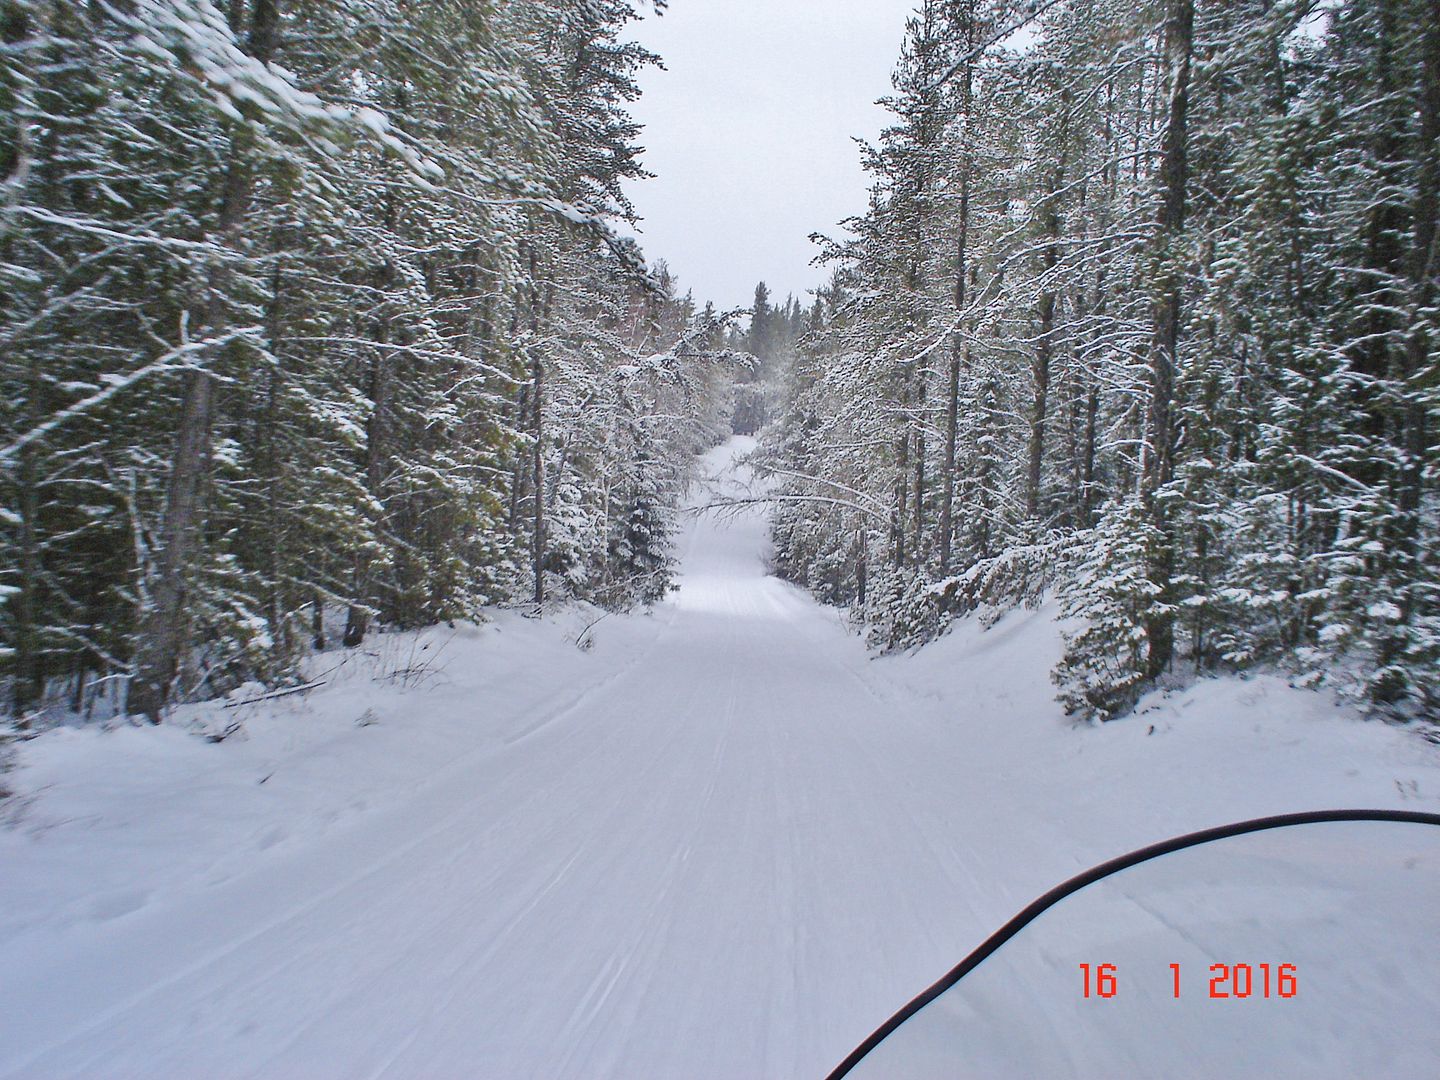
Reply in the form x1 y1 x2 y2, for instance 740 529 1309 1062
827 809 1440 1080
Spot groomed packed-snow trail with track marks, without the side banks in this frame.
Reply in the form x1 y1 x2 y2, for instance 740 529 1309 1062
0 440 1002 1077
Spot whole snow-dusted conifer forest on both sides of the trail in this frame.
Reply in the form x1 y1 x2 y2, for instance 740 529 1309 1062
0 0 1440 726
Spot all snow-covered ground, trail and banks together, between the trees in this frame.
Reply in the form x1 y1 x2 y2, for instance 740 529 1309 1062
0 439 1440 1080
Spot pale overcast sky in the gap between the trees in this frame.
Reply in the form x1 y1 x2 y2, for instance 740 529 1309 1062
631 0 913 308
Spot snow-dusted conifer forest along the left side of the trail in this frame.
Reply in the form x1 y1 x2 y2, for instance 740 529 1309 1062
0 0 736 726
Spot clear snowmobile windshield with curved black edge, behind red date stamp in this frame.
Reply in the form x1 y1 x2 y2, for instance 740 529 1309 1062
831 811 1440 1080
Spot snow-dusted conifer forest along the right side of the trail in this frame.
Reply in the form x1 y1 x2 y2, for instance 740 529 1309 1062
762 0 1440 719
